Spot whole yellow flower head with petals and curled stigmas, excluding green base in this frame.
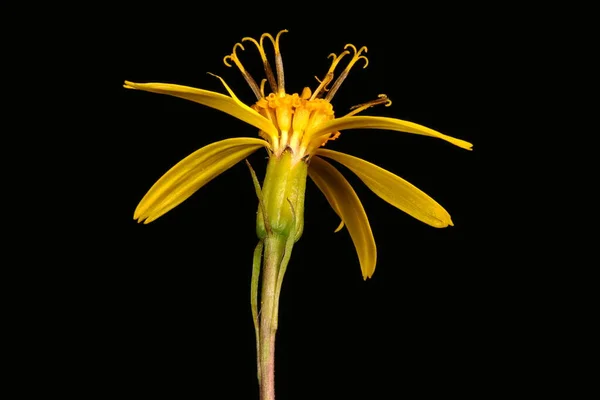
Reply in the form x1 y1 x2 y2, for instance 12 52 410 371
124 30 472 279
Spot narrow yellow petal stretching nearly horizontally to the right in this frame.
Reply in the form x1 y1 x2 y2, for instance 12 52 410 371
308 116 473 150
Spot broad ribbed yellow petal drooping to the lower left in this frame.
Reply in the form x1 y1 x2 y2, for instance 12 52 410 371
133 138 268 223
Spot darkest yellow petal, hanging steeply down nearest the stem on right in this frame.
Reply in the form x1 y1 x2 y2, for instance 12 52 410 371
308 157 377 279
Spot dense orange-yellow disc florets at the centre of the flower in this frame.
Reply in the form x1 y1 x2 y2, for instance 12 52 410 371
252 93 339 161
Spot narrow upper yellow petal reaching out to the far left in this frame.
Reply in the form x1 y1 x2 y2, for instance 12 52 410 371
123 78 278 136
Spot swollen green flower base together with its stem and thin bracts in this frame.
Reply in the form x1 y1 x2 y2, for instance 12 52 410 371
248 151 308 400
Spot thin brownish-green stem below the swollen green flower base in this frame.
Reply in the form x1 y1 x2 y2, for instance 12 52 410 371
259 235 286 400
